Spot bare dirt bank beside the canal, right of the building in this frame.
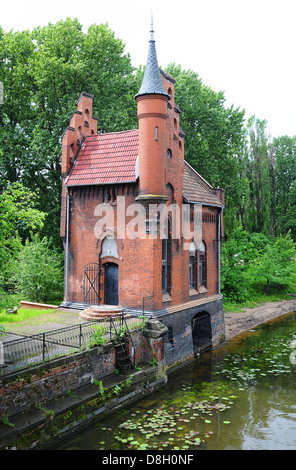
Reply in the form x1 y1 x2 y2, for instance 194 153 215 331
225 299 296 340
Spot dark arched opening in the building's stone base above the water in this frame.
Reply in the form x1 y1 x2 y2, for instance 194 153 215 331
191 312 212 356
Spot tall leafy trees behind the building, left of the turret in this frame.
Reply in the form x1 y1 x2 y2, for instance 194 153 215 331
0 18 138 247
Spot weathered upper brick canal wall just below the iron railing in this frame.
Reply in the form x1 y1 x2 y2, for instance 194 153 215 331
0 324 158 416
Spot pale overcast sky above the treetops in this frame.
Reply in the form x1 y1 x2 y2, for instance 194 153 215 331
0 0 296 137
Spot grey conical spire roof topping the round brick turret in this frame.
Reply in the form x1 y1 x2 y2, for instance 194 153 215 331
135 20 170 98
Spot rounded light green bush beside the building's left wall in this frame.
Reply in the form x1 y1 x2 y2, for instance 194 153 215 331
11 234 64 302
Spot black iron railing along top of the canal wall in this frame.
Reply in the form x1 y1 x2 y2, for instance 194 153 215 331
0 314 143 376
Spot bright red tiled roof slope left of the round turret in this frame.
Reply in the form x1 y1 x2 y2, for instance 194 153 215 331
66 129 139 186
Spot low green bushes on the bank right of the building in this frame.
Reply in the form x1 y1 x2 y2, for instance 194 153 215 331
221 226 296 302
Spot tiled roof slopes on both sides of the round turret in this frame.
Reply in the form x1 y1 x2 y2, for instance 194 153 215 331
65 129 223 207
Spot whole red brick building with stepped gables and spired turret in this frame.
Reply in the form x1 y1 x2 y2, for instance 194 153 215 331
61 24 224 363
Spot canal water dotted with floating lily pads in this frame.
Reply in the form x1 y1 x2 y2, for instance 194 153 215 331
55 312 296 450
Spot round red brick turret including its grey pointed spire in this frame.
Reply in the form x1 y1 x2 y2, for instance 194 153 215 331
135 20 170 201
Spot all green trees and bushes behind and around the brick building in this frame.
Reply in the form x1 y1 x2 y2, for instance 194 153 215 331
0 18 296 309
